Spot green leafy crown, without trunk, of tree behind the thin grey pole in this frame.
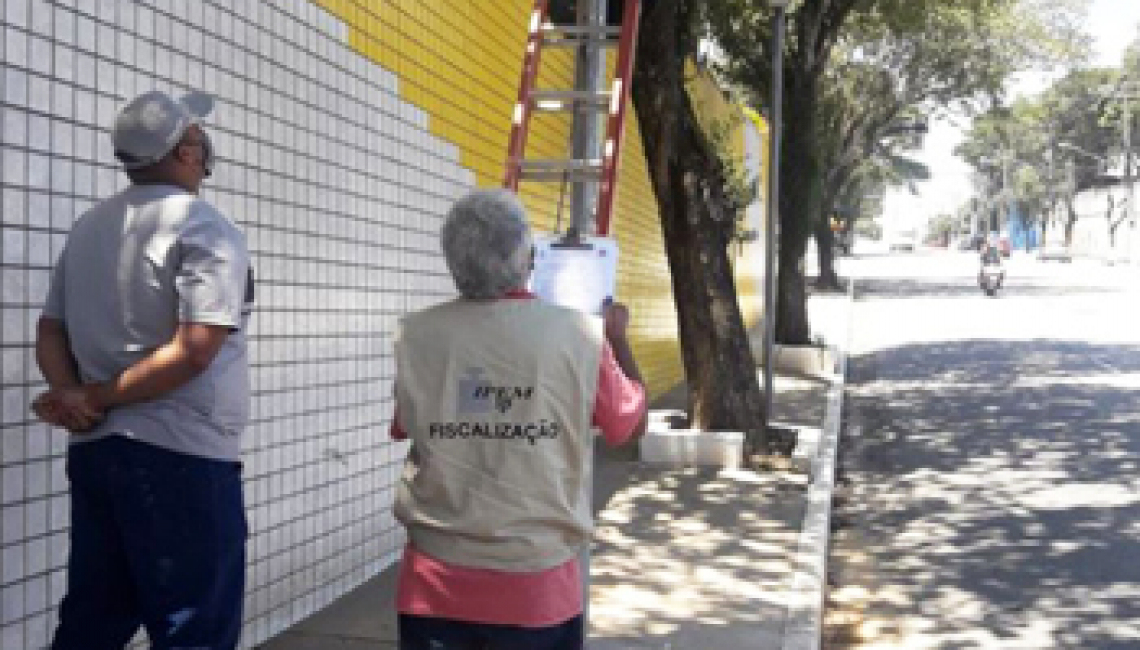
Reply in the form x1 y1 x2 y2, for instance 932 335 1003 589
703 0 1085 232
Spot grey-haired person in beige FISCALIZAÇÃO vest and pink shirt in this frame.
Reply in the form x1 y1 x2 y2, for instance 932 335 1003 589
392 189 646 650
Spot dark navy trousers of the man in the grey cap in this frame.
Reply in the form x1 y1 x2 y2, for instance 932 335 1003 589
51 436 247 650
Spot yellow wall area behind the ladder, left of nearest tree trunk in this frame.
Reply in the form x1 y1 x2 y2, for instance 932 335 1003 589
312 0 683 396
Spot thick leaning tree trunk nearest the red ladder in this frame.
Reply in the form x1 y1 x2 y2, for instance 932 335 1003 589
632 0 768 458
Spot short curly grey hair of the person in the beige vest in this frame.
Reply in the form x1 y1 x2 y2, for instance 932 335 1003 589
440 189 532 299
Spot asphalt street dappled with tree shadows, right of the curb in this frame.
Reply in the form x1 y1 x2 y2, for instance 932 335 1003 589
824 250 1140 650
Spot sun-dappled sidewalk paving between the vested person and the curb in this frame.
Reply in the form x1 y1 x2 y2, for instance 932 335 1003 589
589 377 828 650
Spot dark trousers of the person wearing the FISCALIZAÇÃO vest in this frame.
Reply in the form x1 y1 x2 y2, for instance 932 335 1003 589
399 614 585 650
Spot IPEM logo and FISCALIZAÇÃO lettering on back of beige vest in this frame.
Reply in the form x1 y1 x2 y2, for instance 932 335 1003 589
428 367 562 445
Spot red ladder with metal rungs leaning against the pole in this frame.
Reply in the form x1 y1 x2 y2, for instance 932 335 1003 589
503 0 641 236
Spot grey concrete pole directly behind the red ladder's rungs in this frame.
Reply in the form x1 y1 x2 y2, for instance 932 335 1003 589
568 0 606 239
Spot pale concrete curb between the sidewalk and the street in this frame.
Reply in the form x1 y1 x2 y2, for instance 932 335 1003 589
780 281 855 650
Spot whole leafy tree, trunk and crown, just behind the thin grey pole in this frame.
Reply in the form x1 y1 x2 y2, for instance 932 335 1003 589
684 0 1086 342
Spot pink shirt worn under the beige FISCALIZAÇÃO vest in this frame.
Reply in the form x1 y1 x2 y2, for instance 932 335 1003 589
391 293 646 627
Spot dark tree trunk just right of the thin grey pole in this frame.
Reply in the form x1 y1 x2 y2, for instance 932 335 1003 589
775 77 822 344
